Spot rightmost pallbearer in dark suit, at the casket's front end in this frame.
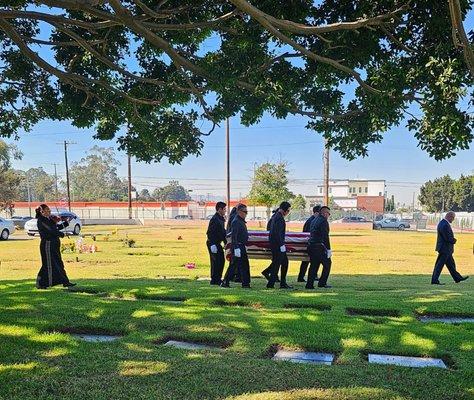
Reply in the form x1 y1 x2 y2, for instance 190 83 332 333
306 206 332 289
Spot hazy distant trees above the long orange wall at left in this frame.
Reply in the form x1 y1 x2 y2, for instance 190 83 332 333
0 140 191 211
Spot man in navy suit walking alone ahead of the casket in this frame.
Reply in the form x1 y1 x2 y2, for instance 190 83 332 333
431 211 469 285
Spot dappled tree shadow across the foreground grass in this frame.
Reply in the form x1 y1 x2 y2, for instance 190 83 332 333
0 275 472 400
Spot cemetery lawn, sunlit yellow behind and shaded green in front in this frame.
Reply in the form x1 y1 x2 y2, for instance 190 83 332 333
0 225 474 400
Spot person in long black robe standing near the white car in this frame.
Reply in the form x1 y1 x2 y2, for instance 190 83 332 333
36 204 76 289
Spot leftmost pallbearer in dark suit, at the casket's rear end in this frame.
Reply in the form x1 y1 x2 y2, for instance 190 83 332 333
206 201 226 285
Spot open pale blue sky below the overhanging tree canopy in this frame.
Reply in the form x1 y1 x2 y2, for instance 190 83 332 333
4 7 474 203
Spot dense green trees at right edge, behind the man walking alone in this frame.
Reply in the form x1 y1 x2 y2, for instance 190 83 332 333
418 175 474 212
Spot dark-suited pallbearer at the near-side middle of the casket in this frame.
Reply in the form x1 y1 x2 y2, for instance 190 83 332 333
267 201 291 289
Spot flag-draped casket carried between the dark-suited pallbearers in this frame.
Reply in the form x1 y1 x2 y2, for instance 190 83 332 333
225 231 310 261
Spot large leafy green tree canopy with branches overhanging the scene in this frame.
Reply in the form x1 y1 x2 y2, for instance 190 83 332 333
0 0 474 162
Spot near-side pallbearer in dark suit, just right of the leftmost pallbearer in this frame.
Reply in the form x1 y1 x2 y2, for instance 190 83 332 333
221 204 250 289
